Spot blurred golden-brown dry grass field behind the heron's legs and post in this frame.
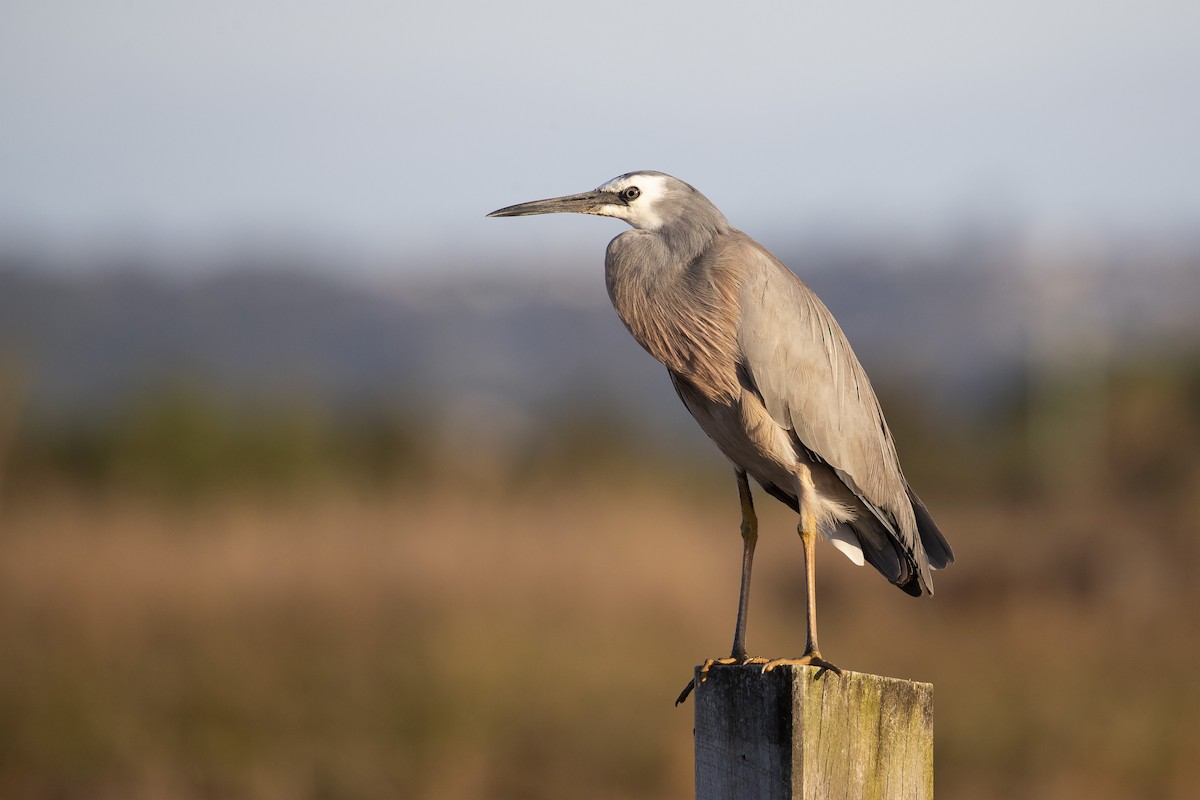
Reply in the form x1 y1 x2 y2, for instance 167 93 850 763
0 476 1200 800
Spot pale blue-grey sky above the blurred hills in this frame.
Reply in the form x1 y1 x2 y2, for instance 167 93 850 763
0 0 1200 271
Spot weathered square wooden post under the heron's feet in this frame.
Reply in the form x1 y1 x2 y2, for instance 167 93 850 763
695 666 934 800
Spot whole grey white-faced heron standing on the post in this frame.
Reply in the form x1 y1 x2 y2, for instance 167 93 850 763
487 172 954 700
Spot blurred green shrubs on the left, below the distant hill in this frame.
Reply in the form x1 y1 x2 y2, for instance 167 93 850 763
7 385 426 499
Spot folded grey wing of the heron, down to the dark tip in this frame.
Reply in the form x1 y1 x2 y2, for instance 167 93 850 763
737 237 949 593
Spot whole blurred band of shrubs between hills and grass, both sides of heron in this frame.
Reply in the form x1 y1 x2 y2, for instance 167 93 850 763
0 356 1200 510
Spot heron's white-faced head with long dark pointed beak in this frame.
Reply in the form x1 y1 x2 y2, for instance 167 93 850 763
487 170 724 230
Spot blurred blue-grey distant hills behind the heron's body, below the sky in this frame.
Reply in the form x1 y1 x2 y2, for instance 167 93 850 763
0 239 1200 438
